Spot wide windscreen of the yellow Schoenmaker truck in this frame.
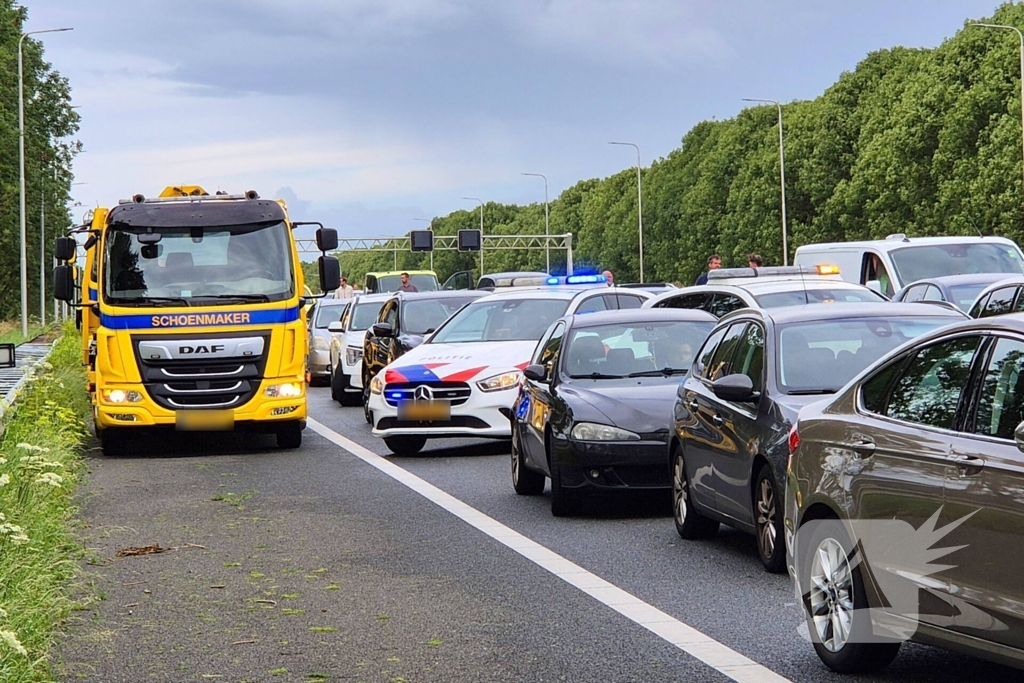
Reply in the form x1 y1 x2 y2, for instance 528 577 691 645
103 221 296 306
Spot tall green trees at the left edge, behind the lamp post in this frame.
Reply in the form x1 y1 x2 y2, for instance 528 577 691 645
0 0 80 319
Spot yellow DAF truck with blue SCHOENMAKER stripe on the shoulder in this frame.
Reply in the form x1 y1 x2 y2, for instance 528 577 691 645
54 185 340 455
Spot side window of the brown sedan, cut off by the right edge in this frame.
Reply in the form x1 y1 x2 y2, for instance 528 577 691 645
974 338 1024 439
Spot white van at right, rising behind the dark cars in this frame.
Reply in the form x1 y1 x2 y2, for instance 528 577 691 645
794 233 1024 297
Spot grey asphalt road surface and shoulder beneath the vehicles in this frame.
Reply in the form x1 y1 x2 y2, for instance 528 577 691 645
58 388 1020 683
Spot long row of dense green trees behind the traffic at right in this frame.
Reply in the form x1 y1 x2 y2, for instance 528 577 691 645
341 3 1024 284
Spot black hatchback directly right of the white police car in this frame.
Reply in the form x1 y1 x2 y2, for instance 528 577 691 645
512 308 716 517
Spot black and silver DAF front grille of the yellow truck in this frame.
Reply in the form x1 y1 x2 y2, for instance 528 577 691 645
132 332 270 411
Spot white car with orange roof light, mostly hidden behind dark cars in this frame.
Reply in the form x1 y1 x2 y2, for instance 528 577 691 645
643 266 886 317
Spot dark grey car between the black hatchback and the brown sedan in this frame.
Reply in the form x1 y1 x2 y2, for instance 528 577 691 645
669 302 966 572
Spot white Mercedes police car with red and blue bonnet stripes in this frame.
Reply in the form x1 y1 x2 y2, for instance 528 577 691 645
368 287 650 455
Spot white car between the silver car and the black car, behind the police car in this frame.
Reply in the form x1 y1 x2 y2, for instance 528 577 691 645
328 293 391 405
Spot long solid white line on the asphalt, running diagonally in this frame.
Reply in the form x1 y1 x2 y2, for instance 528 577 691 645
306 418 790 683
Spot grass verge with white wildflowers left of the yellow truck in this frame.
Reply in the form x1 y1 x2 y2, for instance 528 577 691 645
0 325 89 683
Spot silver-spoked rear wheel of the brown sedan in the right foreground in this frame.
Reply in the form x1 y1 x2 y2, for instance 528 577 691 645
796 519 901 674
